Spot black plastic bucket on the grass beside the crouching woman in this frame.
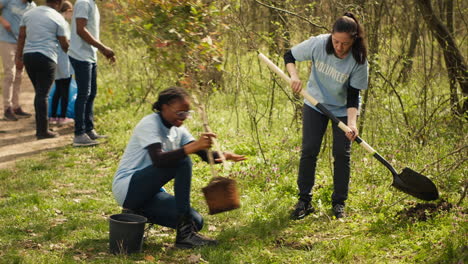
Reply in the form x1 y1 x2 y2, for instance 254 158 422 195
109 214 148 254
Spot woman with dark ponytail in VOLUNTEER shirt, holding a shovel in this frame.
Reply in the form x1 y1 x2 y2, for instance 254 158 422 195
284 12 368 219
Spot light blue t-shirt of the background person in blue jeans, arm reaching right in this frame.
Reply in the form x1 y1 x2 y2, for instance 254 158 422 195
68 0 100 63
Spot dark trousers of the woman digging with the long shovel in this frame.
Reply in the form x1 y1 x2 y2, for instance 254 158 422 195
297 105 351 205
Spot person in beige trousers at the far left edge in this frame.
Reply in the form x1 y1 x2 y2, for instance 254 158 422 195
0 0 36 121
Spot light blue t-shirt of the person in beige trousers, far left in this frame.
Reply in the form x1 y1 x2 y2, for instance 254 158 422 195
0 0 36 44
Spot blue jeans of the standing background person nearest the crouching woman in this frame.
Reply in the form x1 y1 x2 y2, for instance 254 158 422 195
70 57 97 135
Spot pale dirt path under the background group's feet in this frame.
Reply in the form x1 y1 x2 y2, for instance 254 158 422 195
0 78 73 169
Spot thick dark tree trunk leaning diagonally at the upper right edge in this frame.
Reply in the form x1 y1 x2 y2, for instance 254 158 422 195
415 0 468 115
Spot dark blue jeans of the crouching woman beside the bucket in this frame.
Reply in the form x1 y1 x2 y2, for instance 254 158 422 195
123 157 203 230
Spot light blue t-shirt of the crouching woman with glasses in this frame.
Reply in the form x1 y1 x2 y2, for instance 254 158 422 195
112 113 194 206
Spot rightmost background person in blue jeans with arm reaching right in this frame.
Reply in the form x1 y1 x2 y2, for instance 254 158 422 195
68 0 115 147
